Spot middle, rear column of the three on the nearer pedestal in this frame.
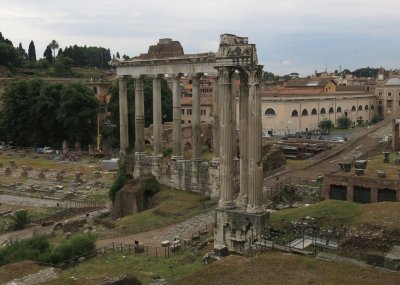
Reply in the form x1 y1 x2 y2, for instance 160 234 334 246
237 71 249 208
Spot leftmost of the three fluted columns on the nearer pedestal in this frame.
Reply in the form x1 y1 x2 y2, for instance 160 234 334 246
218 67 235 209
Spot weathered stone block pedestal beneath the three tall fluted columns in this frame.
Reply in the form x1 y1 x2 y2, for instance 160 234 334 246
214 208 269 253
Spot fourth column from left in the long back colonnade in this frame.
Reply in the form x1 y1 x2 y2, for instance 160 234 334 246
172 74 183 160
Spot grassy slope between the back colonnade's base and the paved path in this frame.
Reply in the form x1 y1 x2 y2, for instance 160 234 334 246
111 188 216 236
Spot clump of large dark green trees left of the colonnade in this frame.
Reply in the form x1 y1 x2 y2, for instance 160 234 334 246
0 79 98 147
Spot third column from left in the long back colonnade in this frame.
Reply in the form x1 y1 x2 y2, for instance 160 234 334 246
153 76 162 156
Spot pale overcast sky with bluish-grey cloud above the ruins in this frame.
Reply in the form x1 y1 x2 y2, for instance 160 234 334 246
0 0 400 75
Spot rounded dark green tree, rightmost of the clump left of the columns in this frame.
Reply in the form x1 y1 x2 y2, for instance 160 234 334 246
57 82 98 144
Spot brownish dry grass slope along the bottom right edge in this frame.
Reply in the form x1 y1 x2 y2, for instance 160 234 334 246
174 252 400 285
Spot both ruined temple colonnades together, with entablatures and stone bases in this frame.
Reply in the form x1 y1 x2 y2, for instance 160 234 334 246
111 34 268 252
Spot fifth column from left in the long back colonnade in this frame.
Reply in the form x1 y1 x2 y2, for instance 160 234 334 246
192 74 201 161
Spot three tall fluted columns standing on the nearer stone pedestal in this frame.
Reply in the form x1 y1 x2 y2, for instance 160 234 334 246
218 66 263 213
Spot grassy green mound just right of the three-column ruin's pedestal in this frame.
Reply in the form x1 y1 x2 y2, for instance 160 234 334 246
271 200 363 228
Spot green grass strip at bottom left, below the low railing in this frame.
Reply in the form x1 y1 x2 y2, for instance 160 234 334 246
43 251 204 285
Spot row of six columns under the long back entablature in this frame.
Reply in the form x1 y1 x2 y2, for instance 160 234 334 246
119 73 219 161
